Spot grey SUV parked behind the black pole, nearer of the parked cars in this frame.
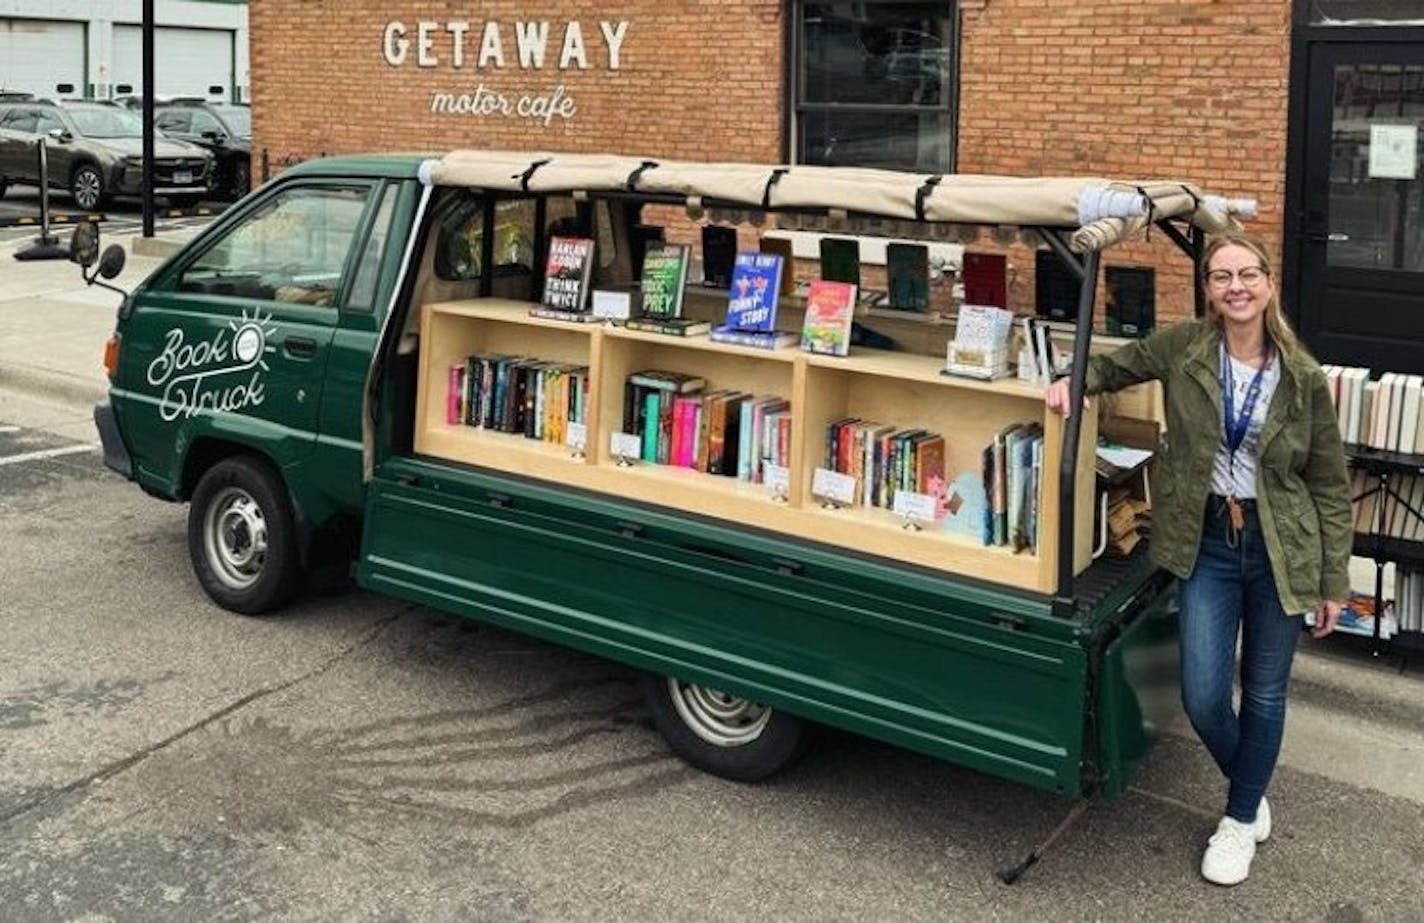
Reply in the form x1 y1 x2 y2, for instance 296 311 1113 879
0 101 214 211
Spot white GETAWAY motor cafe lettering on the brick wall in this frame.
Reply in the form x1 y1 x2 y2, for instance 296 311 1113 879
380 20 628 125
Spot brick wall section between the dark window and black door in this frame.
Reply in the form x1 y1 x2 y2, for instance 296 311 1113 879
958 0 1290 323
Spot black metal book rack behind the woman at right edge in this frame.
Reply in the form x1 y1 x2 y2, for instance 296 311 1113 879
1346 444 1424 655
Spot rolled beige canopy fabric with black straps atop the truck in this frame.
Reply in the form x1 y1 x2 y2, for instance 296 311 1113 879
423 150 1256 251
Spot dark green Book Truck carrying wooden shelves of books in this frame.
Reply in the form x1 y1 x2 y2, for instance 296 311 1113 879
77 151 1233 831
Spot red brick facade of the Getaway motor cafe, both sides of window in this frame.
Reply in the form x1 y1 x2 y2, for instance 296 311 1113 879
251 0 1290 322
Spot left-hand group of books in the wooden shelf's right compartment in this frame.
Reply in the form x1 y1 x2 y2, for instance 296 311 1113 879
822 417 947 518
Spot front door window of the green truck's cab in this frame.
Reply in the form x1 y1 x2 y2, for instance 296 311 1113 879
178 185 370 308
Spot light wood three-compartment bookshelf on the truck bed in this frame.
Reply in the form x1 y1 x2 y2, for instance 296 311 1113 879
414 298 1096 594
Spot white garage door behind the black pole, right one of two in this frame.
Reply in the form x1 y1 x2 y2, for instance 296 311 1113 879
114 26 232 100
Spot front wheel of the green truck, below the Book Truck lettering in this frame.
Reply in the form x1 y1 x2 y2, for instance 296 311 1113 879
188 456 300 615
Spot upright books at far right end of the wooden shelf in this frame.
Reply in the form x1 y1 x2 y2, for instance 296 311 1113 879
984 423 1044 554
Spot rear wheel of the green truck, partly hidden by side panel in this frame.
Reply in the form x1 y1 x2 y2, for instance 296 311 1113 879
642 674 809 782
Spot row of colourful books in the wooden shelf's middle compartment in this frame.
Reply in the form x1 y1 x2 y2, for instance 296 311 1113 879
622 369 790 483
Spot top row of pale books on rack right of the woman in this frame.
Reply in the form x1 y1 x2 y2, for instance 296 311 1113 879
1320 365 1424 454
